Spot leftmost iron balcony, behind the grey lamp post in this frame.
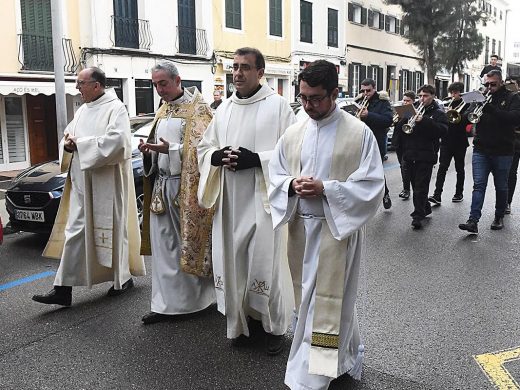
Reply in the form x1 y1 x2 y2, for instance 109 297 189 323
18 34 79 74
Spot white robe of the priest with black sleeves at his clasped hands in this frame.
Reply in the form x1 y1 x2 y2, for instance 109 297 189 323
198 85 294 338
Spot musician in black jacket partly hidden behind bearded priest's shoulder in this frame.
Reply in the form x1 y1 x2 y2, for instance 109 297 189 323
359 79 393 209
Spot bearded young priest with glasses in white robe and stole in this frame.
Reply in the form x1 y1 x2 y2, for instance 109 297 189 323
269 60 384 390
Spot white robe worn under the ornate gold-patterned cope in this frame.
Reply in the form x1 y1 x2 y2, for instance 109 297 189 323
145 88 215 314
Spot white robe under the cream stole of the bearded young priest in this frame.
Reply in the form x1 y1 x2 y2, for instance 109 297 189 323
269 107 384 390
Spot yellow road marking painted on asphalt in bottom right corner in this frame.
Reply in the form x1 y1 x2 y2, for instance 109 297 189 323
473 347 520 390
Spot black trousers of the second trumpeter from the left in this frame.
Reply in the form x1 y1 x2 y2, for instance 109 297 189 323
406 161 433 218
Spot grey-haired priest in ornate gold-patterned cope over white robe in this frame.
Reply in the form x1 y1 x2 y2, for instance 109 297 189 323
139 60 215 324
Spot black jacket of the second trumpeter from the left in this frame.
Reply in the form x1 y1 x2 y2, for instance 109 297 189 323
394 101 448 164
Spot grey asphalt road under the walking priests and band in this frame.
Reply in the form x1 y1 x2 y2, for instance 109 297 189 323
0 147 520 390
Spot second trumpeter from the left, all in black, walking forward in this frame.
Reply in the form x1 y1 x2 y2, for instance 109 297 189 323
394 85 448 229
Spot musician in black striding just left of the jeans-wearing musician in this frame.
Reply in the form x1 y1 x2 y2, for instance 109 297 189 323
428 82 469 205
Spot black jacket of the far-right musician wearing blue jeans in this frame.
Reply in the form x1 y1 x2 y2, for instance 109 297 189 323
473 86 520 156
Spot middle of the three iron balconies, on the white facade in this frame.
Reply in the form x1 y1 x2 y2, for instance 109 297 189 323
110 15 152 50
